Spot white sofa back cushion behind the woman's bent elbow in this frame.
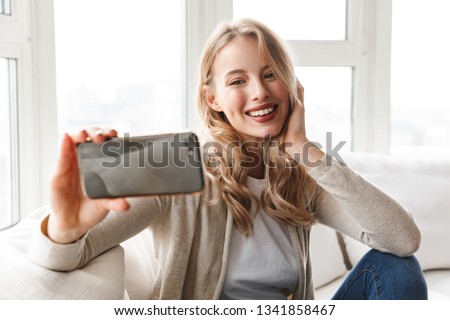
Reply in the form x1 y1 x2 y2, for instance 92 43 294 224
343 153 450 270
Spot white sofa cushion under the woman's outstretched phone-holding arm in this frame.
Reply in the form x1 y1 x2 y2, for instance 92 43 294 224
0 207 127 300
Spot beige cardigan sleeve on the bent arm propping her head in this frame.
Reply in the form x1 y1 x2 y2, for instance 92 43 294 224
310 155 421 256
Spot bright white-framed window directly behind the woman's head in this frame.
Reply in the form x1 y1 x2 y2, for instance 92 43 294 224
193 0 392 153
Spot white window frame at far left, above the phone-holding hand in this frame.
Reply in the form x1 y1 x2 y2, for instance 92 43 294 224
0 0 57 220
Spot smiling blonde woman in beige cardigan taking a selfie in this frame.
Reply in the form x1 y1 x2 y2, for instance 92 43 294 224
29 19 427 299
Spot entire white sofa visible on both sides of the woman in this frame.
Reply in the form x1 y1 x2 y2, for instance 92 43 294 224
0 153 450 300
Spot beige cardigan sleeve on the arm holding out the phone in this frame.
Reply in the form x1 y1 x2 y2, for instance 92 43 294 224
27 196 169 271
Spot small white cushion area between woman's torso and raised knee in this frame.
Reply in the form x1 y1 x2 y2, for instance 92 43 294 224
310 224 347 289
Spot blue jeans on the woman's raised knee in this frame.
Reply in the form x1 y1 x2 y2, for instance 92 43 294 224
332 249 428 300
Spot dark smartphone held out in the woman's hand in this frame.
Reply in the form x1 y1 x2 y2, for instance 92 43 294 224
77 132 204 199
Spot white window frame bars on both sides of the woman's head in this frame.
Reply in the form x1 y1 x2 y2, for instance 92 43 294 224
187 0 392 154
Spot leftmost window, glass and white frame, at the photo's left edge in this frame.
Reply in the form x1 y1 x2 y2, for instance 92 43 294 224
0 0 47 225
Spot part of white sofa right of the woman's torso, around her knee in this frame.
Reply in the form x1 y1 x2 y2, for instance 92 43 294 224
311 153 450 299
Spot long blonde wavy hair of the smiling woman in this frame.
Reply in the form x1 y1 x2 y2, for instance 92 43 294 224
197 19 316 236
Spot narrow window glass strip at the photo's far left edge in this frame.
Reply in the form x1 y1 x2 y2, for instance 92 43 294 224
0 58 17 230
